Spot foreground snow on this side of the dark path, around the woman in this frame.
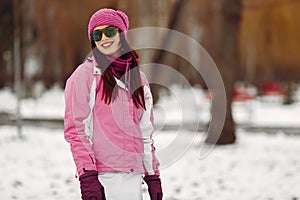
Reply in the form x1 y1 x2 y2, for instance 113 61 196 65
0 126 300 200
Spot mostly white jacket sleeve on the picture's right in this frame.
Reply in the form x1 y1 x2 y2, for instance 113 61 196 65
140 85 160 175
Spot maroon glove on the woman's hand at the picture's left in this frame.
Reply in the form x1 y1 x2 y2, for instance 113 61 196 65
79 171 106 200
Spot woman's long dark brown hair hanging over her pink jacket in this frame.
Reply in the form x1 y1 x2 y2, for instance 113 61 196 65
91 32 146 109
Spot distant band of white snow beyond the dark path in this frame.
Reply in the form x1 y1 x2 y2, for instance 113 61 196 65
0 83 300 128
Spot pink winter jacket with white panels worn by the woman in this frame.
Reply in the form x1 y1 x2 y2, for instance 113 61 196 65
64 59 159 175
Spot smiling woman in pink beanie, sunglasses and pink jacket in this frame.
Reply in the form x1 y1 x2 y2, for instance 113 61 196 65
64 8 162 200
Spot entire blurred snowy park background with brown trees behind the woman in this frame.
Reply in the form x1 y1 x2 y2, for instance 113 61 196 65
0 0 300 200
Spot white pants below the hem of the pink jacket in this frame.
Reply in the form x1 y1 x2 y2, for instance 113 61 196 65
99 172 143 200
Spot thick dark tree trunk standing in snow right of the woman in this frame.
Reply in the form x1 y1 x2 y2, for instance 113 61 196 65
206 0 242 144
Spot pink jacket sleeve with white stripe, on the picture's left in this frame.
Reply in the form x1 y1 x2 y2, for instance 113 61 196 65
64 65 97 176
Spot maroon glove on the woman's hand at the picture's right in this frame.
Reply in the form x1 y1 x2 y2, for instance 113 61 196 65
144 175 163 200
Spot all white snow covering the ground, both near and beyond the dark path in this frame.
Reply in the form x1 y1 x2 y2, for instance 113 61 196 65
0 86 300 200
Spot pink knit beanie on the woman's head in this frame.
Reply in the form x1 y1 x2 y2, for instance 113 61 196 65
88 8 129 40
